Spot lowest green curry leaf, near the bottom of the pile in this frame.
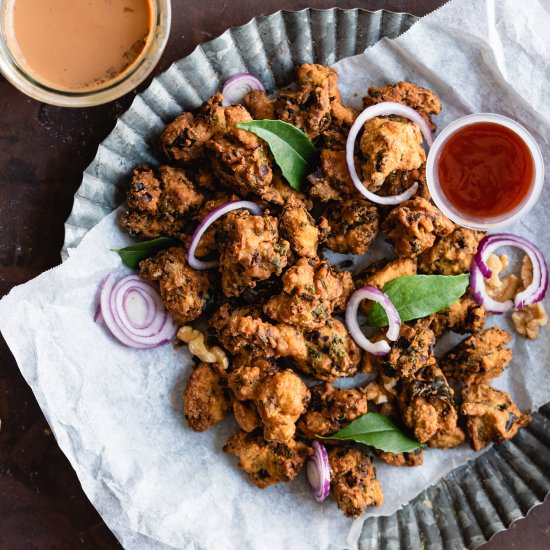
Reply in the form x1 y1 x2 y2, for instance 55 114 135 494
323 413 422 453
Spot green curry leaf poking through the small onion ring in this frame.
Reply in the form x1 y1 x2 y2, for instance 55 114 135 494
367 274 470 327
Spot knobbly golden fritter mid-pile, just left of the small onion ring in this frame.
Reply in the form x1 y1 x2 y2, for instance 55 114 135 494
264 258 353 330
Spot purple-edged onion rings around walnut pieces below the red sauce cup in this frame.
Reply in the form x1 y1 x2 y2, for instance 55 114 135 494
470 233 548 313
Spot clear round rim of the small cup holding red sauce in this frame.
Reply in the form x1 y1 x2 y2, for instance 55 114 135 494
426 113 544 231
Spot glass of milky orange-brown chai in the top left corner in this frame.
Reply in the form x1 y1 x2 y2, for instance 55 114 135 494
0 0 171 107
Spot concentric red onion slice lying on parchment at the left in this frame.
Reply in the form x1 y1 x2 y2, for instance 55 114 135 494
100 275 177 349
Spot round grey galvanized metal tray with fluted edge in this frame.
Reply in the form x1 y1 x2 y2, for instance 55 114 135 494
62 8 550 550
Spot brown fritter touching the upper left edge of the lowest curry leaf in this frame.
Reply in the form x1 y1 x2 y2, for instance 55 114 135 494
297 382 368 439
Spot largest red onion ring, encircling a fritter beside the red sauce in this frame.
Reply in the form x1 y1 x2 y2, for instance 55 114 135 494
346 101 433 204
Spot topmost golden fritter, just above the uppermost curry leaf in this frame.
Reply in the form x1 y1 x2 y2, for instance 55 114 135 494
275 64 341 140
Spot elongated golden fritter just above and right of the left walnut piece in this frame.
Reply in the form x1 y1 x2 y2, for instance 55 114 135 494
210 304 308 359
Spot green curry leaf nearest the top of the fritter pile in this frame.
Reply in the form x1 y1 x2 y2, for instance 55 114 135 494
237 120 318 191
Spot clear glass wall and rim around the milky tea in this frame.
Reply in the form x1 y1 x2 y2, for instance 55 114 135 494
0 0 172 107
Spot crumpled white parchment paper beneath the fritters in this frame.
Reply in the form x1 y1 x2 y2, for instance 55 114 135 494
0 0 550 550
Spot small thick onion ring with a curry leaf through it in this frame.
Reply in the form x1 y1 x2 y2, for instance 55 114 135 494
346 286 401 355
